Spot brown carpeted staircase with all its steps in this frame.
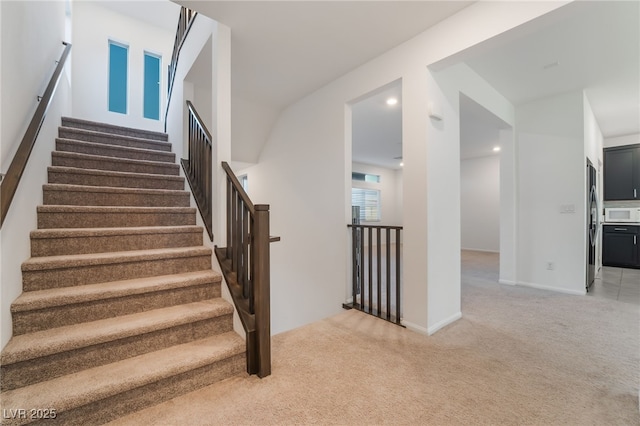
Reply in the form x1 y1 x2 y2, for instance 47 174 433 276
0 118 246 425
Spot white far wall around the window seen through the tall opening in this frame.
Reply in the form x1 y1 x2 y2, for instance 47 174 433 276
351 163 402 226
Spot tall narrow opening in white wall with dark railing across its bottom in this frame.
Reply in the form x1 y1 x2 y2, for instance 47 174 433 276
345 80 404 324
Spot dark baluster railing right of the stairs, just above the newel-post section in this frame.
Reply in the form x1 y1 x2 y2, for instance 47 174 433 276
180 101 213 241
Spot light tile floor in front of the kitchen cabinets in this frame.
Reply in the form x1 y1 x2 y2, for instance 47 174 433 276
587 266 640 305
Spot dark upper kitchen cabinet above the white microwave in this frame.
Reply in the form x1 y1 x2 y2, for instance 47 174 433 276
604 144 640 201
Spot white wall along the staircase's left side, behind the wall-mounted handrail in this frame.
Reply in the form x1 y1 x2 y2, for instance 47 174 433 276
0 1 71 347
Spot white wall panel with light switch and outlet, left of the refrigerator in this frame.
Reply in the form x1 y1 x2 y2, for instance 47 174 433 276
516 91 586 294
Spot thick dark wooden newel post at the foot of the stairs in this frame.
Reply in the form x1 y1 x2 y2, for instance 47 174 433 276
253 204 271 378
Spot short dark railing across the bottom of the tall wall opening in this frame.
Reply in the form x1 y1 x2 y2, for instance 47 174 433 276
342 225 402 325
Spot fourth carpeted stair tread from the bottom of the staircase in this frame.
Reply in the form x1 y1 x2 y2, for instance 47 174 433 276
22 246 211 272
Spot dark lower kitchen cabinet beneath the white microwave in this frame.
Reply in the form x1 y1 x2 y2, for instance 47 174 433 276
602 225 640 268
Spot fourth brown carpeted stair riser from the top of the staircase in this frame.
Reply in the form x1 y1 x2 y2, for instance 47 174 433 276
51 151 180 176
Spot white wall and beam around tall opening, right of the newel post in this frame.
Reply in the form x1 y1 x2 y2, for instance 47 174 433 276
234 2 560 333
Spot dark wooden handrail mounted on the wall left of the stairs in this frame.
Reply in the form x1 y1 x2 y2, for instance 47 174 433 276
0 41 71 227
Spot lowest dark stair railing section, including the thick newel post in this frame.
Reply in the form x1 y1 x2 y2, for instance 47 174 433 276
215 162 280 377
